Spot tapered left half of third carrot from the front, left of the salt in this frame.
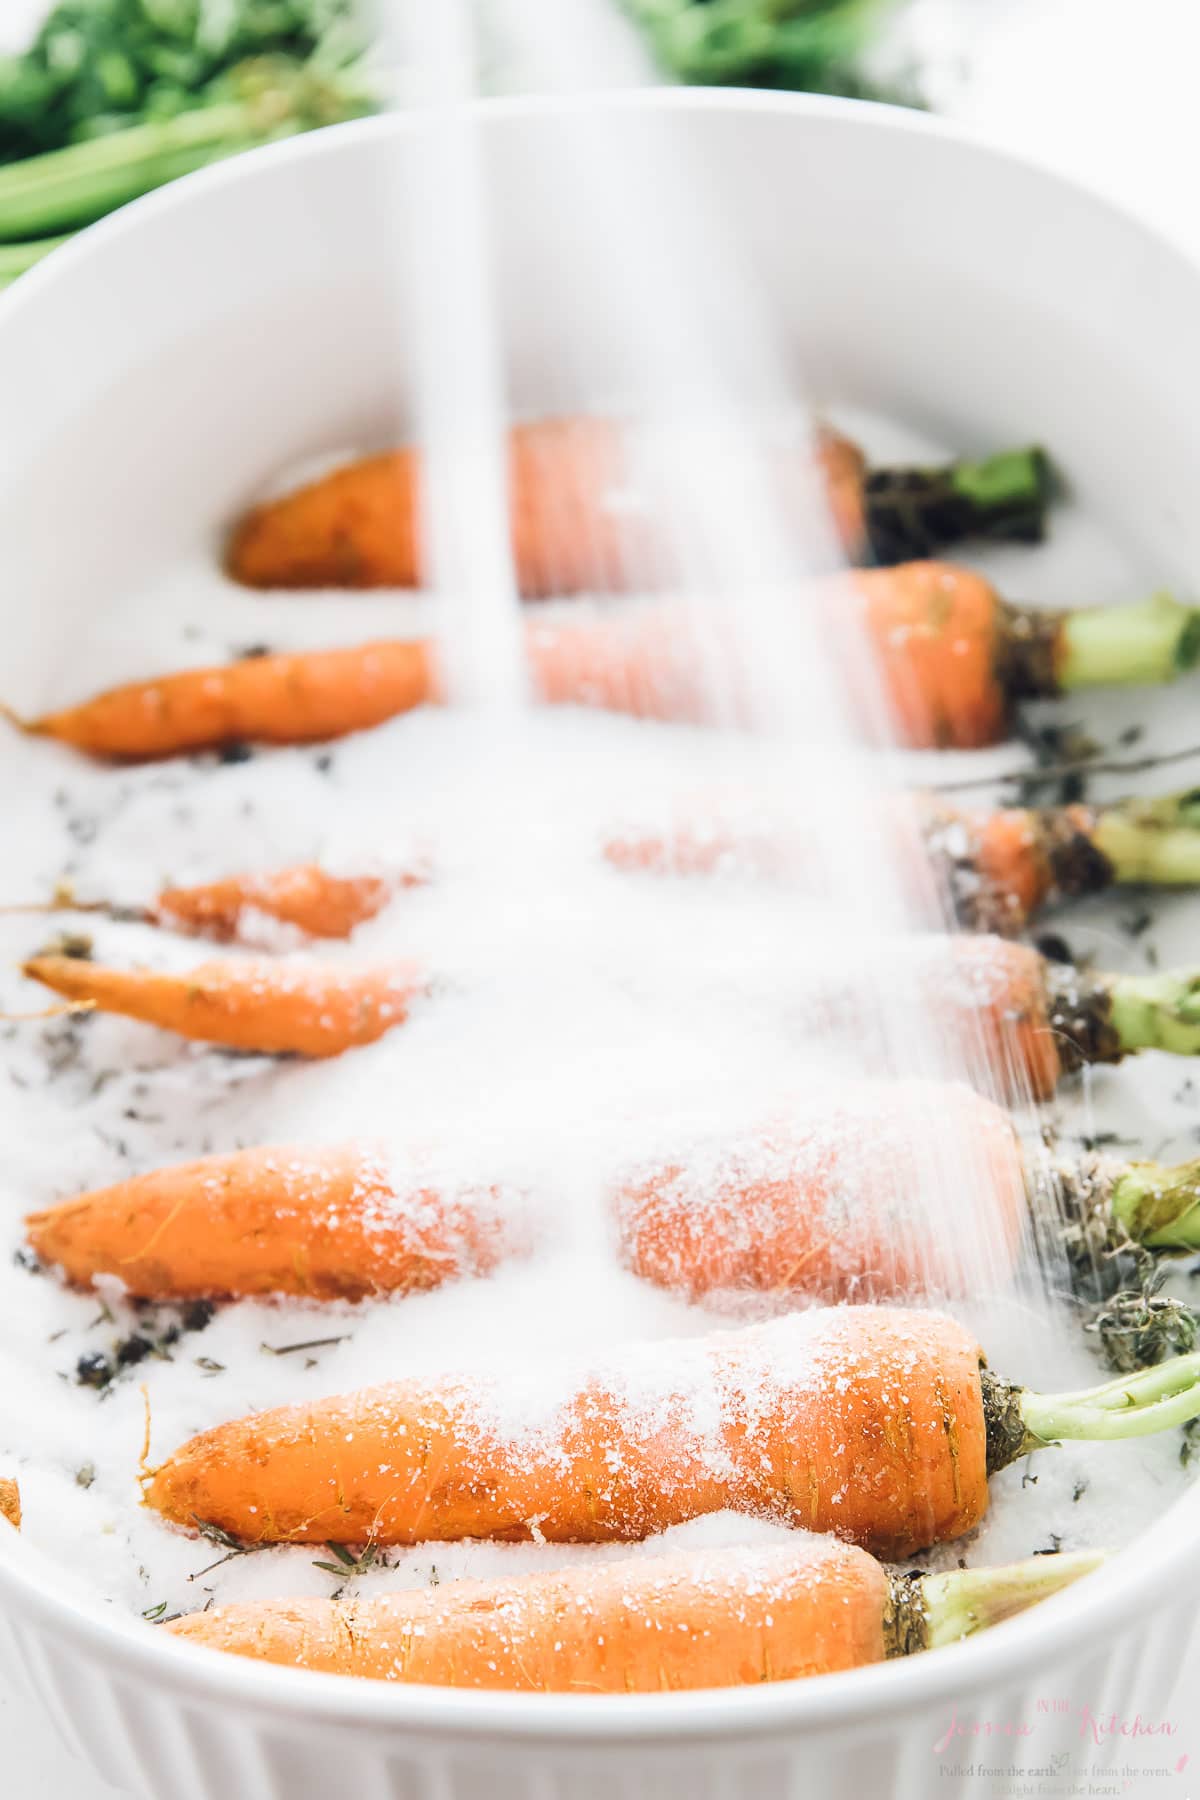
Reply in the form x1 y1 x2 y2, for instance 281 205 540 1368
25 1145 524 1300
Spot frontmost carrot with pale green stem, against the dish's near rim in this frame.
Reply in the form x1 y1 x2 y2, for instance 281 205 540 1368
167 1537 1103 1694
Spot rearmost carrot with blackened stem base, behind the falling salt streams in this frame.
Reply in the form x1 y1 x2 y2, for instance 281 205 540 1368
227 418 1047 598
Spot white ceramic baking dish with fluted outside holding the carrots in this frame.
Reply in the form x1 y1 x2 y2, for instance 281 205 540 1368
0 94 1200 1800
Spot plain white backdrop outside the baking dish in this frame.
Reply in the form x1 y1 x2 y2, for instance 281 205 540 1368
0 0 1200 1800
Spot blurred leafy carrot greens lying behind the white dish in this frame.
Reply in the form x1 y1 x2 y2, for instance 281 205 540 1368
0 0 918 288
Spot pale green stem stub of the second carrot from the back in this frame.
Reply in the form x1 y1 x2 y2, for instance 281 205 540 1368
1054 592 1200 693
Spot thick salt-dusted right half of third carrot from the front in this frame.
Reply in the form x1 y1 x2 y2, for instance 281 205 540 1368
613 1082 1025 1301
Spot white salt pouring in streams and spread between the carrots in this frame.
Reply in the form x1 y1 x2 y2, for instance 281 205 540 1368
5 7 1177 1684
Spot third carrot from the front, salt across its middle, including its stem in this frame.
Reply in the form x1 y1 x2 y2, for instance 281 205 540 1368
25 1082 1200 1301
